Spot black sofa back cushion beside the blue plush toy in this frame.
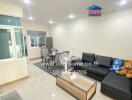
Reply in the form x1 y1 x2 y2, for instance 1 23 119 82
95 55 112 67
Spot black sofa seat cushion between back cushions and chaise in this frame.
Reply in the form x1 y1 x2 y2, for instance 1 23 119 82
86 66 109 77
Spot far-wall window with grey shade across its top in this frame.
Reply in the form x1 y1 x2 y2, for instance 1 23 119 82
28 30 46 47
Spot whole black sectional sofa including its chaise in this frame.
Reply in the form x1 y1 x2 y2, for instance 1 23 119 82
72 53 132 100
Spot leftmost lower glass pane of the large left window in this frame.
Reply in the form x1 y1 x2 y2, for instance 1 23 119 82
0 29 13 59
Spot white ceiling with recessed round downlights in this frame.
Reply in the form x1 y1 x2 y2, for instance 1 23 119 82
0 0 132 25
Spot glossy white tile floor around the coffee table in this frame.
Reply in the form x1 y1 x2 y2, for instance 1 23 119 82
0 60 112 100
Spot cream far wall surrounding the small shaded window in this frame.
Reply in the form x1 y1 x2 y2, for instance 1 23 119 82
23 22 50 59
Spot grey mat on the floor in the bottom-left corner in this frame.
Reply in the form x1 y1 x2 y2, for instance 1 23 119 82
0 90 23 100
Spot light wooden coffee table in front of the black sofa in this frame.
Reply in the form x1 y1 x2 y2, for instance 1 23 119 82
56 72 97 100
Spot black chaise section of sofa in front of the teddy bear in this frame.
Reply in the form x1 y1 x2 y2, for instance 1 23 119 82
101 72 132 100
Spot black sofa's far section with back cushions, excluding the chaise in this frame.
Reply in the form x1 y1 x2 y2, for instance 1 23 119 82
73 53 112 81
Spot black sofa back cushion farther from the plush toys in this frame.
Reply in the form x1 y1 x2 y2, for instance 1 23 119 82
82 53 95 63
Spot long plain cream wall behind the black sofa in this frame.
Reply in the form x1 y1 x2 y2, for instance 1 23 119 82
51 9 132 59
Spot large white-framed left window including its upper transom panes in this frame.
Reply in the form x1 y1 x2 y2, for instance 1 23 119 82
0 15 25 60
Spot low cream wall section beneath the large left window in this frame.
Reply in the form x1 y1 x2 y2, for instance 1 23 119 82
0 58 28 86
